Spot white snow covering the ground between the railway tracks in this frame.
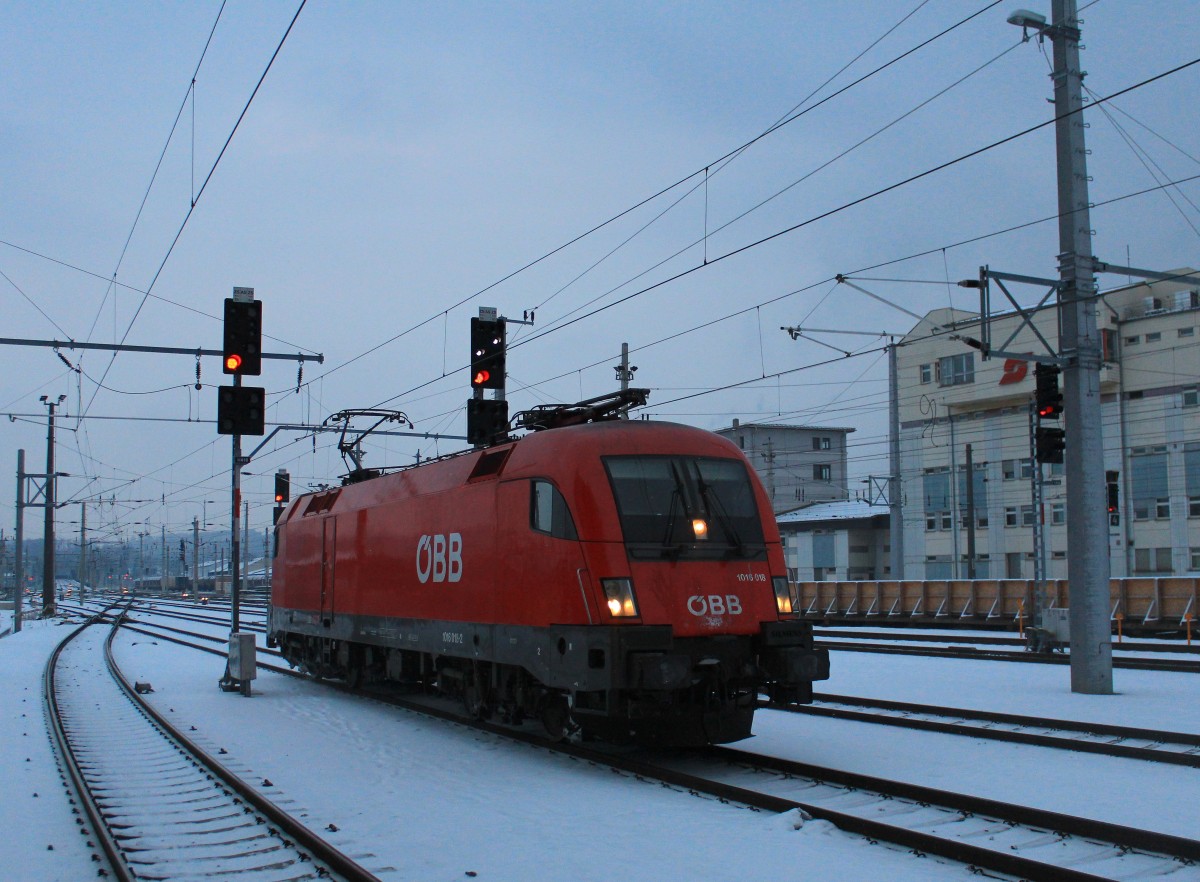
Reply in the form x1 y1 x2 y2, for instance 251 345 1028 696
0 607 1200 882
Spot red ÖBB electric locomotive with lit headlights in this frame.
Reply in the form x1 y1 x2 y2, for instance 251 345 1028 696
268 400 829 745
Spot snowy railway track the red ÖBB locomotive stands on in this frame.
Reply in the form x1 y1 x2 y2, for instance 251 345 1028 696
112 607 1200 882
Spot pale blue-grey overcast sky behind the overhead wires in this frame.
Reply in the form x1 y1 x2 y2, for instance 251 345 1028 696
0 0 1200 552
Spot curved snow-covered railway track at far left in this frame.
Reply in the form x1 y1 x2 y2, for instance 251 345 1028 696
44 616 377 882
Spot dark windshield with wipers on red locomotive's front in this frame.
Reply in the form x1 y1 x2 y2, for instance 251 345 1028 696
604 456 767 560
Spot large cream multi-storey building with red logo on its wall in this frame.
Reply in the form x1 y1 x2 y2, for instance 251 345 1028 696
898 269 1200 578
